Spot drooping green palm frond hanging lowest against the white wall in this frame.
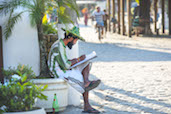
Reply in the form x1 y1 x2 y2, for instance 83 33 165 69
4 11 23 40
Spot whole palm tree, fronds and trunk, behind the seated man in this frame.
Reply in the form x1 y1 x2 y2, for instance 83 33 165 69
0 0 78 76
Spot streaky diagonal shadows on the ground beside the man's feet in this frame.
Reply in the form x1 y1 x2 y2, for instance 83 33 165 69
90 75 171 114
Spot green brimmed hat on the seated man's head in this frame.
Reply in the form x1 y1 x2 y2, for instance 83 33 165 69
62 26 85 41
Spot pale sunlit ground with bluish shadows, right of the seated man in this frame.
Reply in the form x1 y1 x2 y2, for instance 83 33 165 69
60 18 171 114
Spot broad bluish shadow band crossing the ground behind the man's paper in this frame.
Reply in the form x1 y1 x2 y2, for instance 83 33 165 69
79 42 171 62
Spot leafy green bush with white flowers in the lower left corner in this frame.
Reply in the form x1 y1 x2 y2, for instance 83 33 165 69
0 66 47 112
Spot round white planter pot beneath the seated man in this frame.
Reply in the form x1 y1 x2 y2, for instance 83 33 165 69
33 79 68 112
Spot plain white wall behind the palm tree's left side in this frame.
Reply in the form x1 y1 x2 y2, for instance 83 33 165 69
0 9 40 75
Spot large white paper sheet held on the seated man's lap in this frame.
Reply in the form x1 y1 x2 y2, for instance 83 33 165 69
70 51 97 69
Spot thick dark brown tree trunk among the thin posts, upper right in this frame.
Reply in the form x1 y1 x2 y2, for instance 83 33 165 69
140 0 151 34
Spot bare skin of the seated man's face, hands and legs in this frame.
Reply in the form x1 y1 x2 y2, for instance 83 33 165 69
63 37 96 112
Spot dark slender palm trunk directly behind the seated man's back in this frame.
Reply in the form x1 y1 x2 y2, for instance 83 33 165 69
37 20 49 77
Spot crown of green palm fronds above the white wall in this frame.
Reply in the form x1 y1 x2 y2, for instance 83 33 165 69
0 0 79 39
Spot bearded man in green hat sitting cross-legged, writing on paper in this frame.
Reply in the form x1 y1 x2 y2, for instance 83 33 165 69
48 27 101 113
